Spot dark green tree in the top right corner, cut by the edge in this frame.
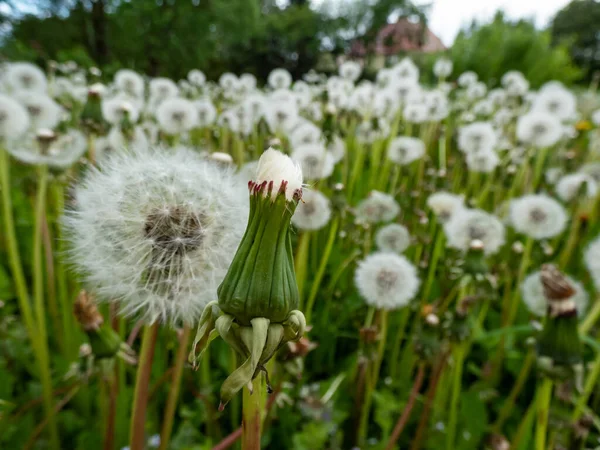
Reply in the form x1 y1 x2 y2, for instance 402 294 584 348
551 0 600 80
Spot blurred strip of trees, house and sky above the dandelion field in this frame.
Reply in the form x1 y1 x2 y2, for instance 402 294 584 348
0 0 600 87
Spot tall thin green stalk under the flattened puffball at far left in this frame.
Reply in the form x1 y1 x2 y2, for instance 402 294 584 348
33 165 60 449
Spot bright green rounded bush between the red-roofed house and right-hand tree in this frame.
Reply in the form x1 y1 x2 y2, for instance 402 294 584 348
451 12 580 88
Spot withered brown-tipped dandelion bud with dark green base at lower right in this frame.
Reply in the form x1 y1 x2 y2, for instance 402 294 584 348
537 264 582 367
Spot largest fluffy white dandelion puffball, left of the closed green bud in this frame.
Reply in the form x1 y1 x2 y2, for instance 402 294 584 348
65 148 248 324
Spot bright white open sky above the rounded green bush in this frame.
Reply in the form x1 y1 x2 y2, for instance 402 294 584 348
413 0 569 46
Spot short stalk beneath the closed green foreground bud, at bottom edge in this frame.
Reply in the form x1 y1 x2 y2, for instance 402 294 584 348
242 372 265 450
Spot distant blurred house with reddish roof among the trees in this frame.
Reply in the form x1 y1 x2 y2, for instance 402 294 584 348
348 18 446 59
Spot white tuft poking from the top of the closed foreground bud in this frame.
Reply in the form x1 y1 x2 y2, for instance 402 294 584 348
252 147 302 201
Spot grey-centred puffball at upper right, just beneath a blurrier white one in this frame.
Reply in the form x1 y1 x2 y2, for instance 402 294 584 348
517 111 562 148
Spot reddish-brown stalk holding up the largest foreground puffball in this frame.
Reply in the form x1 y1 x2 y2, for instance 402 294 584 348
129 323 158 450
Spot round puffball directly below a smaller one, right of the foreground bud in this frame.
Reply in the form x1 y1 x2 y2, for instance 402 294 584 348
354 252 420 310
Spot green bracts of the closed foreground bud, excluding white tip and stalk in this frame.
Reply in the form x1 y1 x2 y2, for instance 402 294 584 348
189 175 306 408
